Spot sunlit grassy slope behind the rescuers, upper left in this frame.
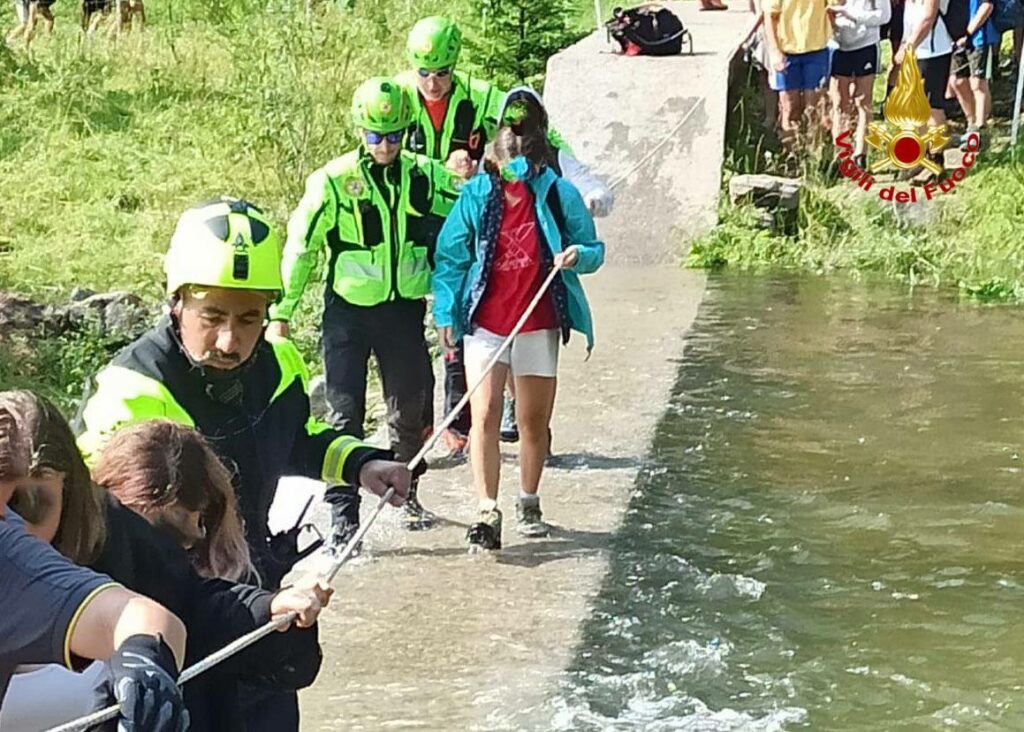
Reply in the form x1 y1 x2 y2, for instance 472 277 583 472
0 0 593 408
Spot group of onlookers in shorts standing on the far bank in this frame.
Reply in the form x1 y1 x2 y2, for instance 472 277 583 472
748 0 1024 180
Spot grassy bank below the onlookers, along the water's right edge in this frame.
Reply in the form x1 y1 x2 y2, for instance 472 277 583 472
689 36 1024 301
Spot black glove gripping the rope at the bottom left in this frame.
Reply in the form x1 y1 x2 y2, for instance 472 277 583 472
98 635 188 732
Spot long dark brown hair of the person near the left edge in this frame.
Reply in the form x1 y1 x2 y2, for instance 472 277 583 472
0 390 106 564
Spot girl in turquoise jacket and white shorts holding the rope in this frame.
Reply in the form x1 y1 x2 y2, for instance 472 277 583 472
433 118 604 549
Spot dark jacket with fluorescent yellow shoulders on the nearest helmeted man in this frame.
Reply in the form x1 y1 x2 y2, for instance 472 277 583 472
75 317 390 582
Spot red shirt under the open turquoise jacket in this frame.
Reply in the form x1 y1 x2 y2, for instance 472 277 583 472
473 180 558 336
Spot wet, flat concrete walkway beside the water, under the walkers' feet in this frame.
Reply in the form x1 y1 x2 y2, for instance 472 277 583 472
273 266 705 730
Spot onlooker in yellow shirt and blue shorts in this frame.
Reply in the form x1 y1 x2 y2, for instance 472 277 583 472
762 0 833 152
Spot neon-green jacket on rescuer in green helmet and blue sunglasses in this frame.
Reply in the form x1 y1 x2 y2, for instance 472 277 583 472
270 147 462 320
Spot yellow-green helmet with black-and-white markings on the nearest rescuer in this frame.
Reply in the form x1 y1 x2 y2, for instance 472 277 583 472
164 196 284 295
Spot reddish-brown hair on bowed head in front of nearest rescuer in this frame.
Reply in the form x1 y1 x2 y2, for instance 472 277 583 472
93 420 254 580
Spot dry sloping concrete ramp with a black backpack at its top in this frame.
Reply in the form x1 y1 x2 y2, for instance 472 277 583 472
544 0 753 263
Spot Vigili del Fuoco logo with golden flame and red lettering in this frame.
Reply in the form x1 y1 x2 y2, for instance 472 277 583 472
836 46 981 204
